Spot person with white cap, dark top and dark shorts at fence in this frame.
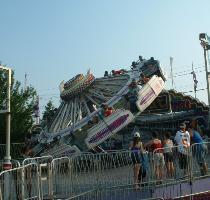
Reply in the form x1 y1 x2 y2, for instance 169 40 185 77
129 132 143 189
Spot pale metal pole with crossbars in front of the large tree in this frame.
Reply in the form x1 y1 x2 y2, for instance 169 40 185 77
0 65 12 170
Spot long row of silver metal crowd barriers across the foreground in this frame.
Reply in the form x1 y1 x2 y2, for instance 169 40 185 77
0 143 210 200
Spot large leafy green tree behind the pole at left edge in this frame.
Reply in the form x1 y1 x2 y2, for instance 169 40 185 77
0 71 36 143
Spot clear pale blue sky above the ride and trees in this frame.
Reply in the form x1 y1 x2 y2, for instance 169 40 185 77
0 0 210 112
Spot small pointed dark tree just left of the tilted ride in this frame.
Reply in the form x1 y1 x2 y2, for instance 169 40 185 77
42 100 57 128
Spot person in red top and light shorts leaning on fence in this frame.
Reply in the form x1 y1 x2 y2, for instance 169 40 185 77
144 132 165 180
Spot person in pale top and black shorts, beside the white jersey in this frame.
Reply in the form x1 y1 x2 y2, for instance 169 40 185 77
163 132 174 177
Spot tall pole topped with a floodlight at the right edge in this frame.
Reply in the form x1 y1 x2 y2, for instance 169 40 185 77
199 33 210 106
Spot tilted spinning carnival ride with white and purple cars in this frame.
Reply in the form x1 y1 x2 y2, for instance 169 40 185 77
33 57 165 156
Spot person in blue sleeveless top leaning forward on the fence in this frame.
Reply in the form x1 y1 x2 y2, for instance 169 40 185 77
188 125 208 176
